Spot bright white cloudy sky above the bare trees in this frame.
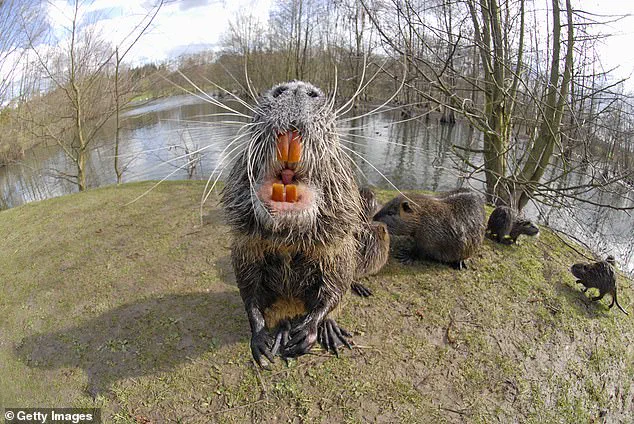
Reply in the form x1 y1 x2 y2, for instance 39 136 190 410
7 0 634 87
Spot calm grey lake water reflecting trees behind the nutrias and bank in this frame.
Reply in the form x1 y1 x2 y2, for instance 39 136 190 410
0 96 634 272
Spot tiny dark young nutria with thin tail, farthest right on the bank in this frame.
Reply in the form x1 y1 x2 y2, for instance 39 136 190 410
570 255 629 315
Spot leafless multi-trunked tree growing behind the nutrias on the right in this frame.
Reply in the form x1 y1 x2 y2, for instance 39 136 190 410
364 0 575 208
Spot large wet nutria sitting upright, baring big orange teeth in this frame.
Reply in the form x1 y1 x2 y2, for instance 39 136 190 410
222 81 386 366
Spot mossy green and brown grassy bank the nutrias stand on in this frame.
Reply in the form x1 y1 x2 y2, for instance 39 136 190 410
0 182 634 423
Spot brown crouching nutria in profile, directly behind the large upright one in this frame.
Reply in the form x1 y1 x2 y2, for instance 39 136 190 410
374 189 486 269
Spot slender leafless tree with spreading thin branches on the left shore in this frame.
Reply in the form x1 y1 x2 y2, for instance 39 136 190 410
23 0 162 191
